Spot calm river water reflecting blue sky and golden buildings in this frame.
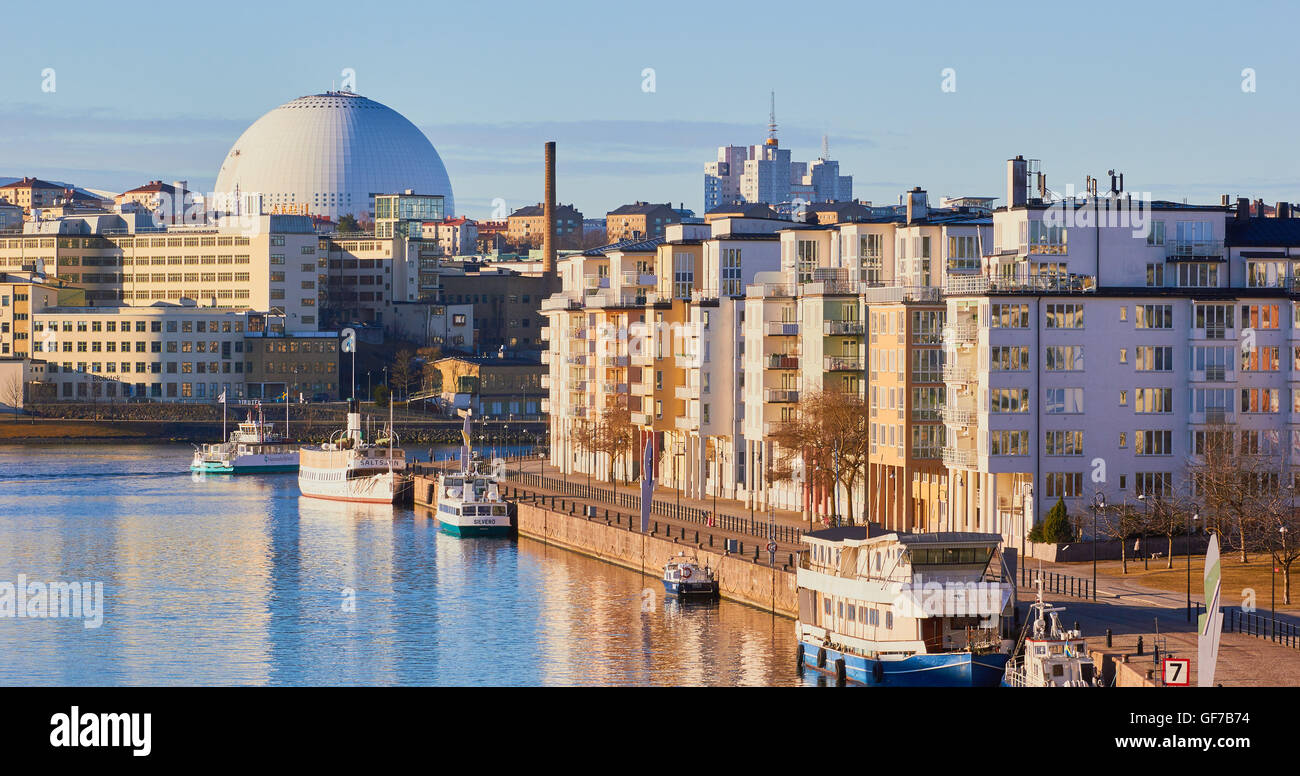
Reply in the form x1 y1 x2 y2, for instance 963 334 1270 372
0 445 818 685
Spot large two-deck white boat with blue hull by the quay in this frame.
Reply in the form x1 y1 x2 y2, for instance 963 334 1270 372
794 526 1014 686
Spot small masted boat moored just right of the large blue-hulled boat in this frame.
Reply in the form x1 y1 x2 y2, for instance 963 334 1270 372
1002 578 1101 688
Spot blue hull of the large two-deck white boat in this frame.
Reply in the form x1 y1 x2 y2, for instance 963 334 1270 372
800 641 1010 688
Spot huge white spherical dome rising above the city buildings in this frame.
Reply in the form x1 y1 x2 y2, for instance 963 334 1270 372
216 91 456 221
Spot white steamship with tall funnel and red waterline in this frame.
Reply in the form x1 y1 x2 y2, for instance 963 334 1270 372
298 399 411 504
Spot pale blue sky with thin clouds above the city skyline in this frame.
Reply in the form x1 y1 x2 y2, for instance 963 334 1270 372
0 0 1300 217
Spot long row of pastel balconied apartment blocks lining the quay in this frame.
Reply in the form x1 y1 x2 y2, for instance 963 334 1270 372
543 159 1300 546
